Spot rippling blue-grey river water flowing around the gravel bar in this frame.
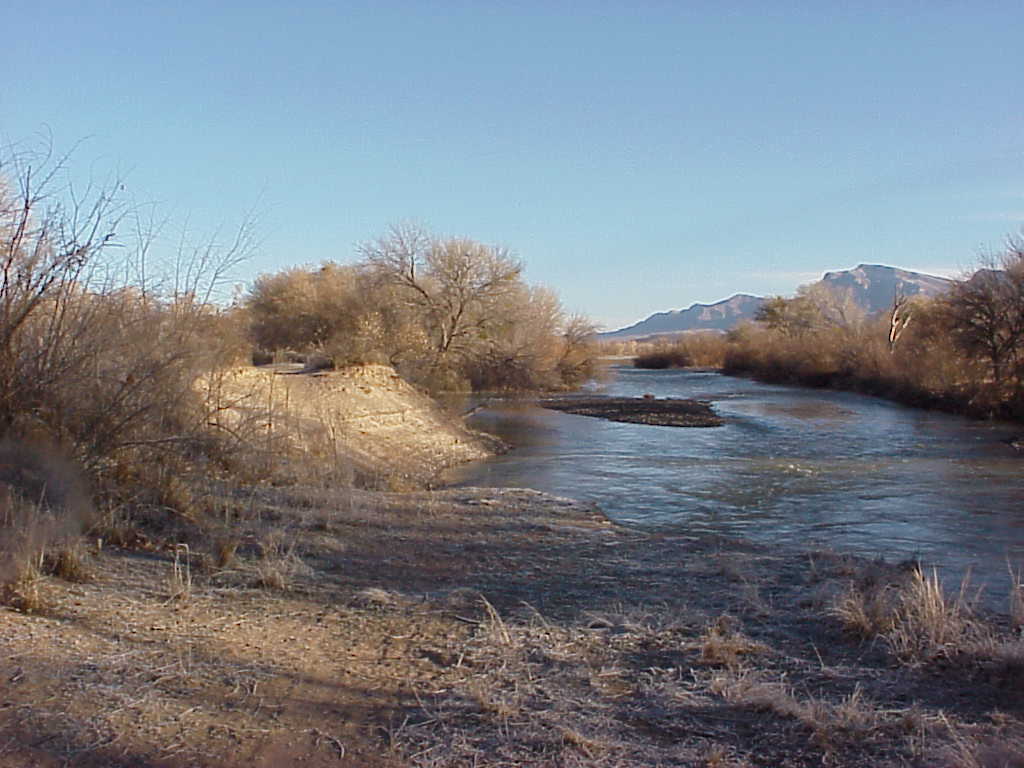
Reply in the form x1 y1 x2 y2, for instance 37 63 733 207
449 367 1024 595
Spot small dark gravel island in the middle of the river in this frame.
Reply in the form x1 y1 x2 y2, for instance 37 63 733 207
539 395 722 427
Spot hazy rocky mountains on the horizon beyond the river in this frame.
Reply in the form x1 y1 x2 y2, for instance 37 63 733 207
599 264 952 341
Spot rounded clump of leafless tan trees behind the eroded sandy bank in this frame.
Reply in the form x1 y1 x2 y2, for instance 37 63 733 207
244 225 596 391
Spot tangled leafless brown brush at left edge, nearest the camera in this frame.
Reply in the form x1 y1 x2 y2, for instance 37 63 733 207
0 141 260 607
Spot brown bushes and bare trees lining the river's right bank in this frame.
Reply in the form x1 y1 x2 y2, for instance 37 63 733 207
635 239 1024 419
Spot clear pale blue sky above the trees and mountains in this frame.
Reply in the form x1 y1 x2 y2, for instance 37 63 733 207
0 0 1024 330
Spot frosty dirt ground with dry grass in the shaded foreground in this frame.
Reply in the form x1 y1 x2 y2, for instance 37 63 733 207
0 487 1024 768
